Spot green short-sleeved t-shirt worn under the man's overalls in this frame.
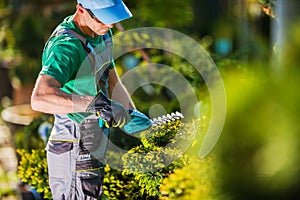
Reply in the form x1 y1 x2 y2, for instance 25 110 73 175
40 16 114 123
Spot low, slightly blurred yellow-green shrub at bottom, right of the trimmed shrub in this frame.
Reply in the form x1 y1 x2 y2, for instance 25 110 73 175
160 156 219 200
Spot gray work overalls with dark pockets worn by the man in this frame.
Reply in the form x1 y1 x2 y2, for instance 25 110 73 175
46 30 109 200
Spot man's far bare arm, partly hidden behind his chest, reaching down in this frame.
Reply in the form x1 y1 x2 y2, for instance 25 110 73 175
108 68 135 109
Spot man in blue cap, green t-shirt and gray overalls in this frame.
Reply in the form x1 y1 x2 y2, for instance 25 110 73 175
31 0 135 200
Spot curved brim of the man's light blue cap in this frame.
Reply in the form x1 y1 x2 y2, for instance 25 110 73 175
91 1 132 24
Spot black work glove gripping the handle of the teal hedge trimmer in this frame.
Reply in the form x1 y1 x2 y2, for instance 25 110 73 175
86 91 130 128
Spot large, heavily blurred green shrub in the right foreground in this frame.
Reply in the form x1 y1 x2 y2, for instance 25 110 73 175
216 68 300 200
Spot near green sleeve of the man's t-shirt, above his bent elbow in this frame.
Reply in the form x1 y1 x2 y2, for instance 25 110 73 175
40 38 80 85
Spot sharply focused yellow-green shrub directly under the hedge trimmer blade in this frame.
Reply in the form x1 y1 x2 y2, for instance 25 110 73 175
123 115 205 199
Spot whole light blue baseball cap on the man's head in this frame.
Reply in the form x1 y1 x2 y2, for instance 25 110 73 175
77 0 132 24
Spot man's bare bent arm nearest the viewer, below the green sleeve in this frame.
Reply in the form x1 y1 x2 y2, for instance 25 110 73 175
31 74 93 114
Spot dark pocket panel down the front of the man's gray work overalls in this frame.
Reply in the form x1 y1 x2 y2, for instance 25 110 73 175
76 119 107 198
